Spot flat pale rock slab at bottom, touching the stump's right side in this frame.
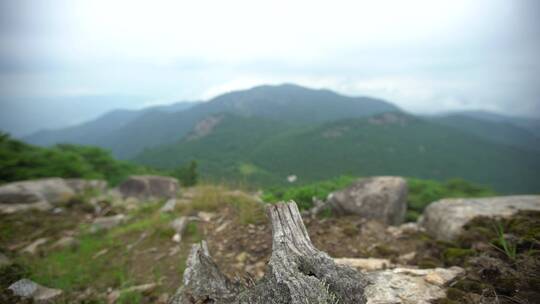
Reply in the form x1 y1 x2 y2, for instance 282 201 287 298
365 267 464 304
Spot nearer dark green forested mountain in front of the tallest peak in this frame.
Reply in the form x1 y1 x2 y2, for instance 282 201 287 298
135 112 540 193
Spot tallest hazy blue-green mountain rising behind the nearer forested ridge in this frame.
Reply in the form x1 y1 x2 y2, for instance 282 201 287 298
26 84 399 159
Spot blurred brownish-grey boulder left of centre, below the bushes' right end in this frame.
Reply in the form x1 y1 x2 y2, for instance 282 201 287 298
118 175 179 199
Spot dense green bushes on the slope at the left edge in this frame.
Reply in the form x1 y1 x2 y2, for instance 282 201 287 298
0 133 159 185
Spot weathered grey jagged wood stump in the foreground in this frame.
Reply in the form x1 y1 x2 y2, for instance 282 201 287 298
169 201 368 304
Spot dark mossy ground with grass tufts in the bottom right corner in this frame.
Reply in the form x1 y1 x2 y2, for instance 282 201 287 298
426 211 540 303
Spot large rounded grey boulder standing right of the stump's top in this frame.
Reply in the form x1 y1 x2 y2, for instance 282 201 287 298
327 176 408 225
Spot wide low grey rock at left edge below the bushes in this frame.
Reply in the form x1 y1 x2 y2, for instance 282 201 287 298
0 178 75 213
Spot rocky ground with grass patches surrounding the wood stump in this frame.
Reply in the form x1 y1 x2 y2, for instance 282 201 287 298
0 177 540 303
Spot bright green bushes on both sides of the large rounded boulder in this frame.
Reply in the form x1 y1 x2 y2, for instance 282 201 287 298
263 176 496 221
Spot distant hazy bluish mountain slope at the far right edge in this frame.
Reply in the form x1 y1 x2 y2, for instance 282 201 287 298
428 112 540 151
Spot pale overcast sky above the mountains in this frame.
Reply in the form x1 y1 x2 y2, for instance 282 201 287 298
0 0 540 124
